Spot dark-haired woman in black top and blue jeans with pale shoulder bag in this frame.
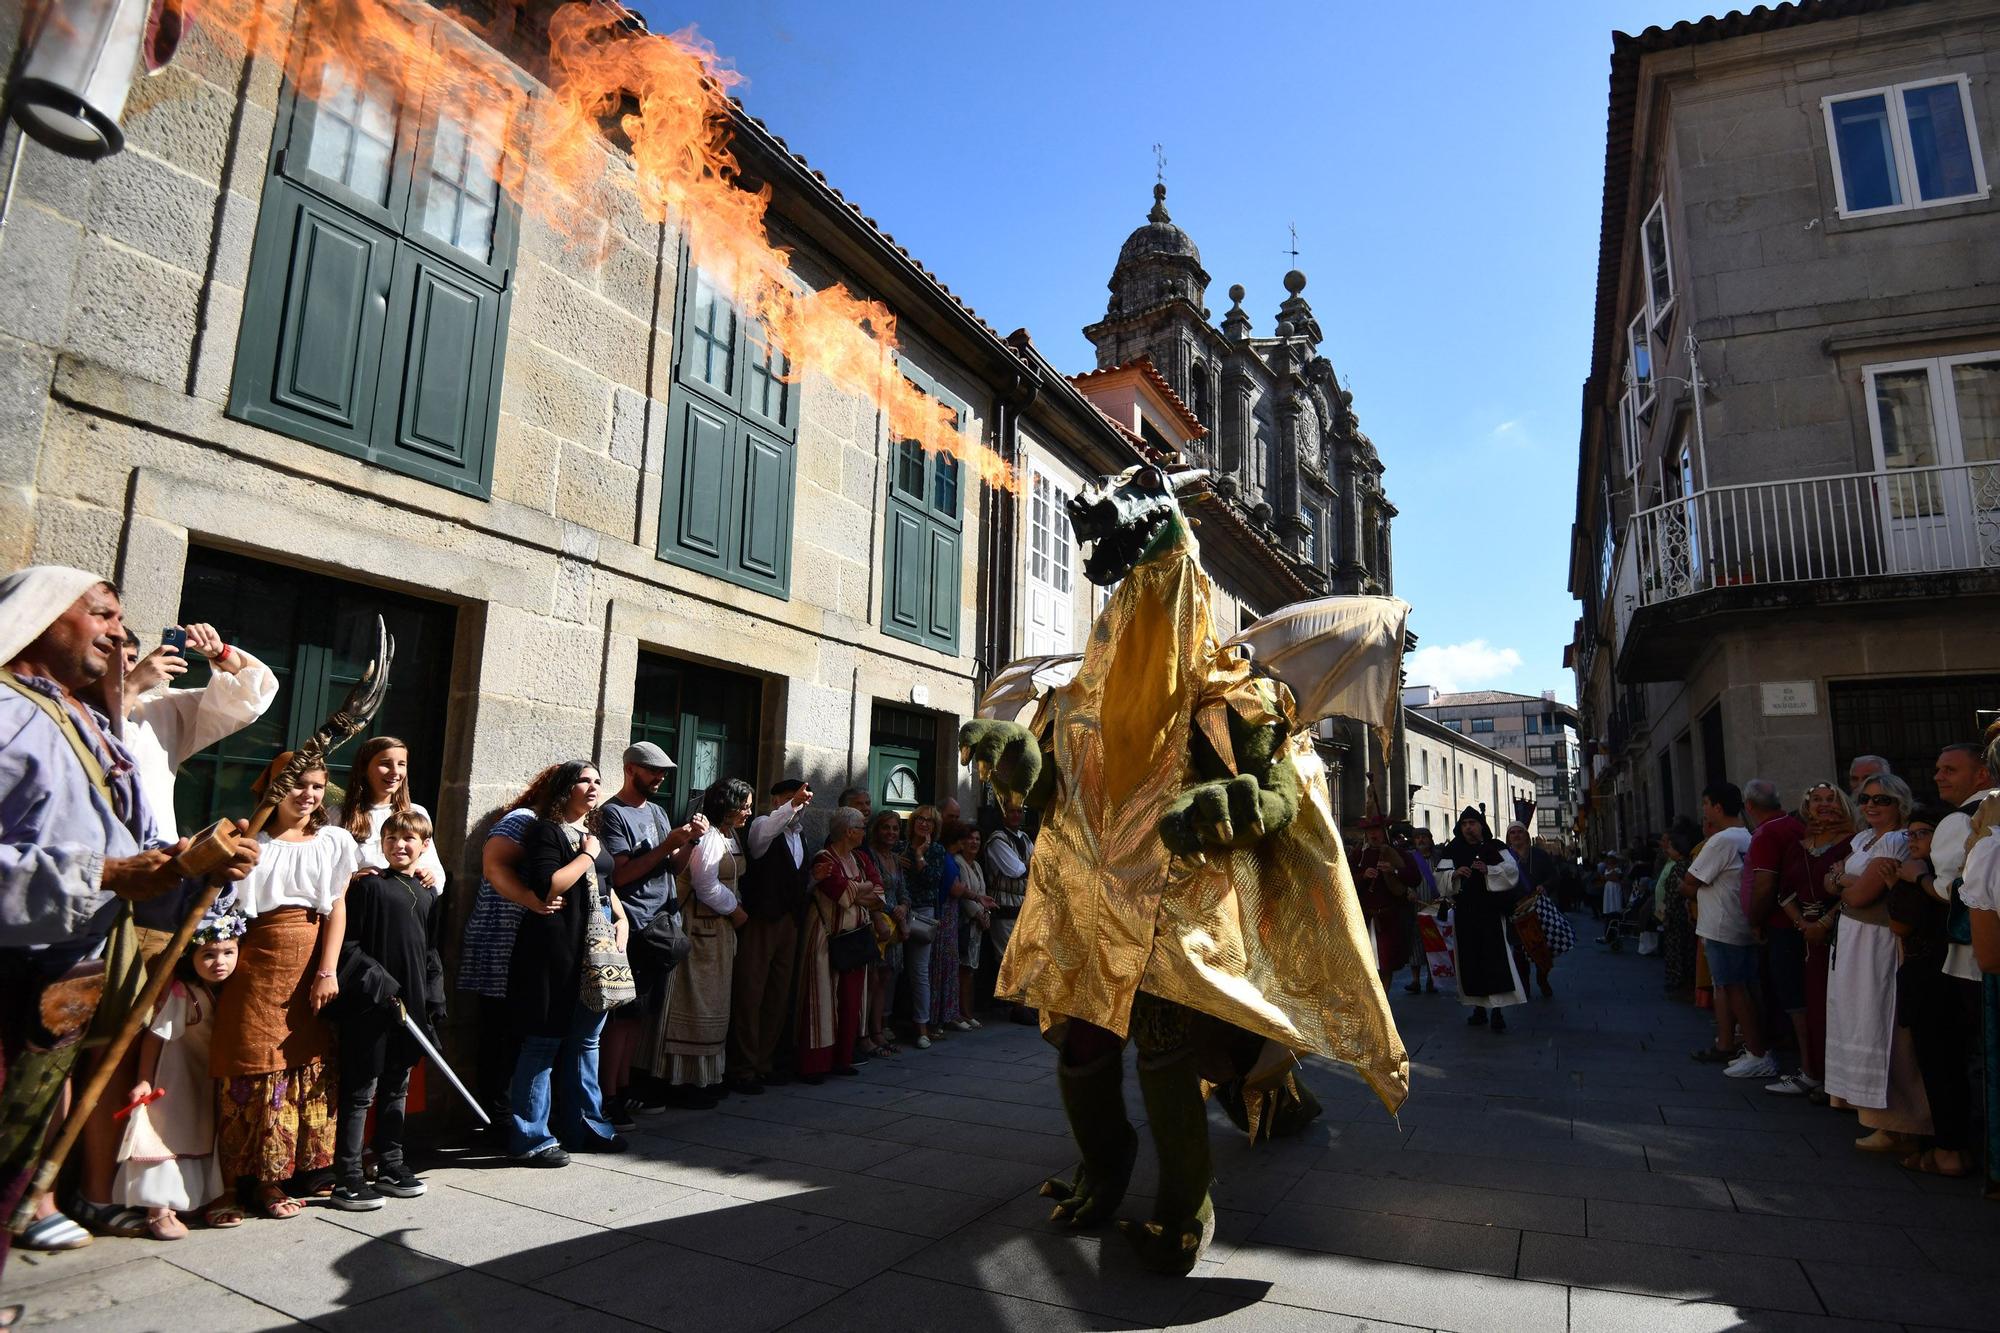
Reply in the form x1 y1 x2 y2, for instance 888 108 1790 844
508 759 626 1167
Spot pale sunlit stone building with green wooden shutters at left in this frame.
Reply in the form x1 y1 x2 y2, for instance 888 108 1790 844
0 2 1022 880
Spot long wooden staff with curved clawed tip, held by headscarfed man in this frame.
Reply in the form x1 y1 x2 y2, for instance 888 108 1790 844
8 616 396 1235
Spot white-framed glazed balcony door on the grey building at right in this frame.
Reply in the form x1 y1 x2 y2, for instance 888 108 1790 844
1862 352 2000 570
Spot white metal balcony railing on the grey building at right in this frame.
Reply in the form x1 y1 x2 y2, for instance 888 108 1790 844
1632 462 2000 606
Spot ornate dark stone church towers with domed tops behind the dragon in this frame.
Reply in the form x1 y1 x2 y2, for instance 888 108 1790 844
1084 184 1396 594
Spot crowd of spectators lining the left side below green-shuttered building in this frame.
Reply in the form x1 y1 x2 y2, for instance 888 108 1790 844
0 566 1034 1288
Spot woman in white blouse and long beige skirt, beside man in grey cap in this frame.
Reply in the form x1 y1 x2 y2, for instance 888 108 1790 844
654 779 752 1101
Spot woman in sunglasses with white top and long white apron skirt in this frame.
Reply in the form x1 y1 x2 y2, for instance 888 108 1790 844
1826 773 1930 1153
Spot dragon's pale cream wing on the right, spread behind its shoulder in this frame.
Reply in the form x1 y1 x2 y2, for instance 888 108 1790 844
1224 596 1410 735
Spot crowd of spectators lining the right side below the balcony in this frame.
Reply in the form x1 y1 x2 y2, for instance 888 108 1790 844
1592 748 2000 1197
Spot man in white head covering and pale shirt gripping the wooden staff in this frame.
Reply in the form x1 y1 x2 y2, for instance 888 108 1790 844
0 564 256 1265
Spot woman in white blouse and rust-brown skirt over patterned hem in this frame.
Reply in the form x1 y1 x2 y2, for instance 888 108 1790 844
208 753 360 1219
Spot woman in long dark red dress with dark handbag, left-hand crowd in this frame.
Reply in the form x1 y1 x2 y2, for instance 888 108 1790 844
798 807 882 1083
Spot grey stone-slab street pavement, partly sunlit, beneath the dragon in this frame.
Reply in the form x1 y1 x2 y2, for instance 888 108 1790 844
4 925 2000 1333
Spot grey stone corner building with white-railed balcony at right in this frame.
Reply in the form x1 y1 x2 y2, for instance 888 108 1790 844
1568 0 2000 847
